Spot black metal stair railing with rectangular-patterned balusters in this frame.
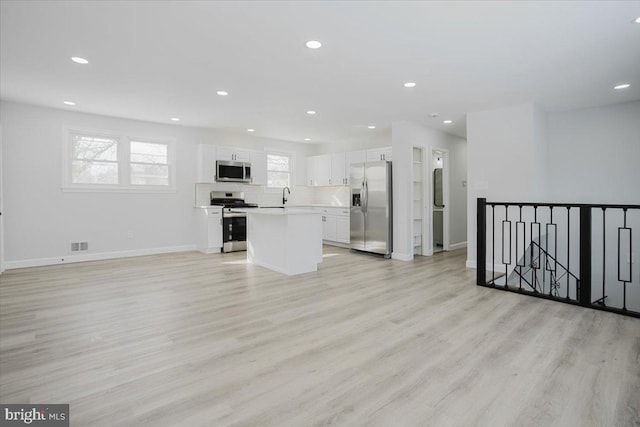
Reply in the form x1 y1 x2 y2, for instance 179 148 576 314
476 198 640 317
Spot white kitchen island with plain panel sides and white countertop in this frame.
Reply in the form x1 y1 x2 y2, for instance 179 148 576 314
247 208 322 276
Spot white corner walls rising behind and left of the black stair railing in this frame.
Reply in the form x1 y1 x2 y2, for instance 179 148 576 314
467 102 640 274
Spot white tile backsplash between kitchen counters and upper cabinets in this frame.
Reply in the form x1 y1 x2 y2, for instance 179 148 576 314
195 182 350 206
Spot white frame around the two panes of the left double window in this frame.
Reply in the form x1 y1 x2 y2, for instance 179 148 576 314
62 126 176 193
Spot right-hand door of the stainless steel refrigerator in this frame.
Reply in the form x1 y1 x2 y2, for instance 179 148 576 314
365 161 389 254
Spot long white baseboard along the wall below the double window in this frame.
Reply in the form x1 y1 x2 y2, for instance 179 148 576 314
4 245 196 270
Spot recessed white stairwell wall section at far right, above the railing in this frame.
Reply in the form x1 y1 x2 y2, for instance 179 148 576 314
547 101 640 204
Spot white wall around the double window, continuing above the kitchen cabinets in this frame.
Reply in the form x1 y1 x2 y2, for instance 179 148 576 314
0 102 308 268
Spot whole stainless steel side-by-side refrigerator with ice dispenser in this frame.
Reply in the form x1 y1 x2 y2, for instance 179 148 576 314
349 161 393 258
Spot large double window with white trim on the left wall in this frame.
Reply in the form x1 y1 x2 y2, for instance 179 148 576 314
63 129 175 192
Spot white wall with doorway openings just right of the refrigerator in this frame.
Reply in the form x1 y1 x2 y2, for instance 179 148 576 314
392 121 467 259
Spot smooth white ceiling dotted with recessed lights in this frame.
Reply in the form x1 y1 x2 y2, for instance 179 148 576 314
0 0 640 142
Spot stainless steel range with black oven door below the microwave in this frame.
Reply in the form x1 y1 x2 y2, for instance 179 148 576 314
211 191 258 252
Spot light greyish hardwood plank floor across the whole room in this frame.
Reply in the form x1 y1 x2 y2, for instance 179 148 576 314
0 247 640 427
